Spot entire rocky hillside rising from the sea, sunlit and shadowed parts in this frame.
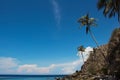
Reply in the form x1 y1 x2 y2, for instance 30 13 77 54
63 28 120 80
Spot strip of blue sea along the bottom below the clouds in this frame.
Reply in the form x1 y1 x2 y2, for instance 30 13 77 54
0 75 65 80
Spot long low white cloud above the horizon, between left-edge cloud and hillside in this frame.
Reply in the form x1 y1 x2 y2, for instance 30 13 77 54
17 59 81 74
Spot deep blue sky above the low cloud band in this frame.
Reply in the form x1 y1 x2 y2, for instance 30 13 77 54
0 0 118 74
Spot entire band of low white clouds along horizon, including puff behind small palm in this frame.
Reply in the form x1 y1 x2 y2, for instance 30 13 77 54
0 47 93 74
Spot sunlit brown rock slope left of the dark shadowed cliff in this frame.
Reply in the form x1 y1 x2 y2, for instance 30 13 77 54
81 45 108 75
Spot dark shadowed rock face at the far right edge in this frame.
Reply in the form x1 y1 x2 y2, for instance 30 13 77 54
107 28 120 78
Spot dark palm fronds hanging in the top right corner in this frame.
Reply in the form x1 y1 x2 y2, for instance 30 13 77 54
97 0 120 22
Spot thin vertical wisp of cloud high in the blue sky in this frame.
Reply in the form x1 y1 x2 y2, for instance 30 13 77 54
51 0 61 25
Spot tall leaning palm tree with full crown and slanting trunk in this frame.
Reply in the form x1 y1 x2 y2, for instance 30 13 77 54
78 14 107 61
